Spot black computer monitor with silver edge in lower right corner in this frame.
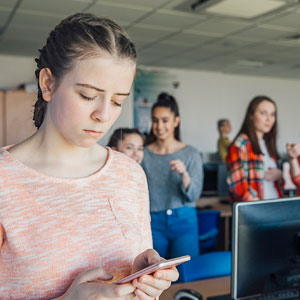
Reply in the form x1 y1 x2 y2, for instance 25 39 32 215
231 197 300 299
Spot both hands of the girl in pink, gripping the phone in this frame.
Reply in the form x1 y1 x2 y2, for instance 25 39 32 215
55 249 183 300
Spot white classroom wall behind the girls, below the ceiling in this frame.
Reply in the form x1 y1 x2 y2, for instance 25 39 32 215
0 56 300 153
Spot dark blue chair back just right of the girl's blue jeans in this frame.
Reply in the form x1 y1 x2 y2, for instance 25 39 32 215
197 210 220 254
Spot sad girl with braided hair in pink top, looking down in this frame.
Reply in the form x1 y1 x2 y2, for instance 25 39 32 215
0 14 178 300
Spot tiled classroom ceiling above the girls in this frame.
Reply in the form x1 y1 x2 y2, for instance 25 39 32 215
0 0 300 79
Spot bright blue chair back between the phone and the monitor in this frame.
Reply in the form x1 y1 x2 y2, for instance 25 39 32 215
178 251 231 282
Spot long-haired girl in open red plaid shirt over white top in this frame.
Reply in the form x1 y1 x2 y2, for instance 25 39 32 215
227 96 282 201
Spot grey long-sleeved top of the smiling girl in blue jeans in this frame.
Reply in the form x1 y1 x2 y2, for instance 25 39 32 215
142 145 203 212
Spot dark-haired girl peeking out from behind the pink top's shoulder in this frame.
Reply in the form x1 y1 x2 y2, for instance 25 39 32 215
107 128 144 164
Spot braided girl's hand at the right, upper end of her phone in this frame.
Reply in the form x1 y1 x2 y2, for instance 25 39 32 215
122 249 179 300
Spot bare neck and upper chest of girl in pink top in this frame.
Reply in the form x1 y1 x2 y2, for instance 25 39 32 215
9 129 108 178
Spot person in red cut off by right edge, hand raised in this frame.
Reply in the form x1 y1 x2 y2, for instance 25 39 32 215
286 143 300 195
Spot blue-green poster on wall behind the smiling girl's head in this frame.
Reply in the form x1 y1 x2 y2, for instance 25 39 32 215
134 69 180 134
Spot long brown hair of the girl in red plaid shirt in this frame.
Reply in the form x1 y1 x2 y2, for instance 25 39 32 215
236 96 280 159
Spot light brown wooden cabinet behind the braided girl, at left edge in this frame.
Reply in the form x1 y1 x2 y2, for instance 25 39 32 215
0 90 37 146
